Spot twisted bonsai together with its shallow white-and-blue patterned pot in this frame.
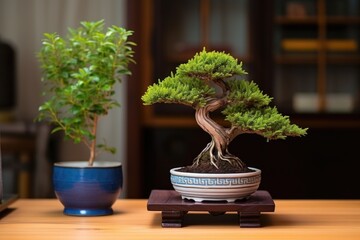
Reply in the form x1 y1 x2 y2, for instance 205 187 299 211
142 48 307 202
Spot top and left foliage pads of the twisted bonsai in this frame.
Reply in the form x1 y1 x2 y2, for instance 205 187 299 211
142 49 246 108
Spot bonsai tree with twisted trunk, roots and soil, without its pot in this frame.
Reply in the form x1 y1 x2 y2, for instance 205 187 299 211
142 49 307 172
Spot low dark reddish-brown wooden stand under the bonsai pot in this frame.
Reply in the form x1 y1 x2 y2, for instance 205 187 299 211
147 190 275 228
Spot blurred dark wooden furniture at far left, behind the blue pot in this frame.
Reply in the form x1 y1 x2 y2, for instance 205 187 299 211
0 121 52 198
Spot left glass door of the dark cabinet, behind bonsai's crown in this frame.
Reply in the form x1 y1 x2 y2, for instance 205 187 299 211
142 0 256 126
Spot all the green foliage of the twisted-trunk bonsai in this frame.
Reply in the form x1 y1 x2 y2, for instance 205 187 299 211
142 49 307 142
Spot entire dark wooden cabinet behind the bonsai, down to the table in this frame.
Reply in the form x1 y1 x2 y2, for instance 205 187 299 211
127 0 360 198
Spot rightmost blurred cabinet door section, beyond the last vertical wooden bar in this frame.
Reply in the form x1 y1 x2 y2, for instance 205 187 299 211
325 0 360 113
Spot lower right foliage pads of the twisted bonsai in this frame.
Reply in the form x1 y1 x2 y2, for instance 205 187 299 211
222 80 306 139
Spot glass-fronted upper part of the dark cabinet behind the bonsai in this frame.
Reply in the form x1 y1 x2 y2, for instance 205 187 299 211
139 0 360 127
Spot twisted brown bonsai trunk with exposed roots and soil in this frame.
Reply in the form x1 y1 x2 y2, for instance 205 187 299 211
191 97 248 172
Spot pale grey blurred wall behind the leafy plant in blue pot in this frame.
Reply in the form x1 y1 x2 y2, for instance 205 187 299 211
0 0 131 197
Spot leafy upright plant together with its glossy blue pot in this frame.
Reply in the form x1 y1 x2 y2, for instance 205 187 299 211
37 20 135 216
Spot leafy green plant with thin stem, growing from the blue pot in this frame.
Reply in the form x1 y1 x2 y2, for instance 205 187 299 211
38 20 135 165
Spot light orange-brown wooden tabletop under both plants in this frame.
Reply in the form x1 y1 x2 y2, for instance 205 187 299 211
0 199 360 240
